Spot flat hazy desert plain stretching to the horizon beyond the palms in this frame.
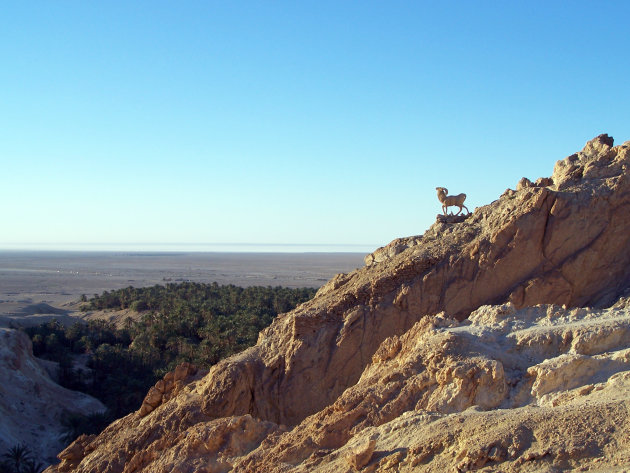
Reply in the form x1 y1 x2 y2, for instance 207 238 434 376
0 251 364 326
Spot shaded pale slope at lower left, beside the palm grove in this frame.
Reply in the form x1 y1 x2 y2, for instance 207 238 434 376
0 327 105 464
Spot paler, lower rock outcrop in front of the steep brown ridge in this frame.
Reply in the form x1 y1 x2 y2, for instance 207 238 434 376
235 299 630 473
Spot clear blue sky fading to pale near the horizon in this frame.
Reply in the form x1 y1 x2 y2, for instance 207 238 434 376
0 0 630 253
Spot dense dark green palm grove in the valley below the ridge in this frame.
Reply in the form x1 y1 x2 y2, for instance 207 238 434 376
21 282 316 450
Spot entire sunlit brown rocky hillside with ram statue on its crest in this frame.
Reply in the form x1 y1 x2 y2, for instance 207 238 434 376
50 135 630 472
